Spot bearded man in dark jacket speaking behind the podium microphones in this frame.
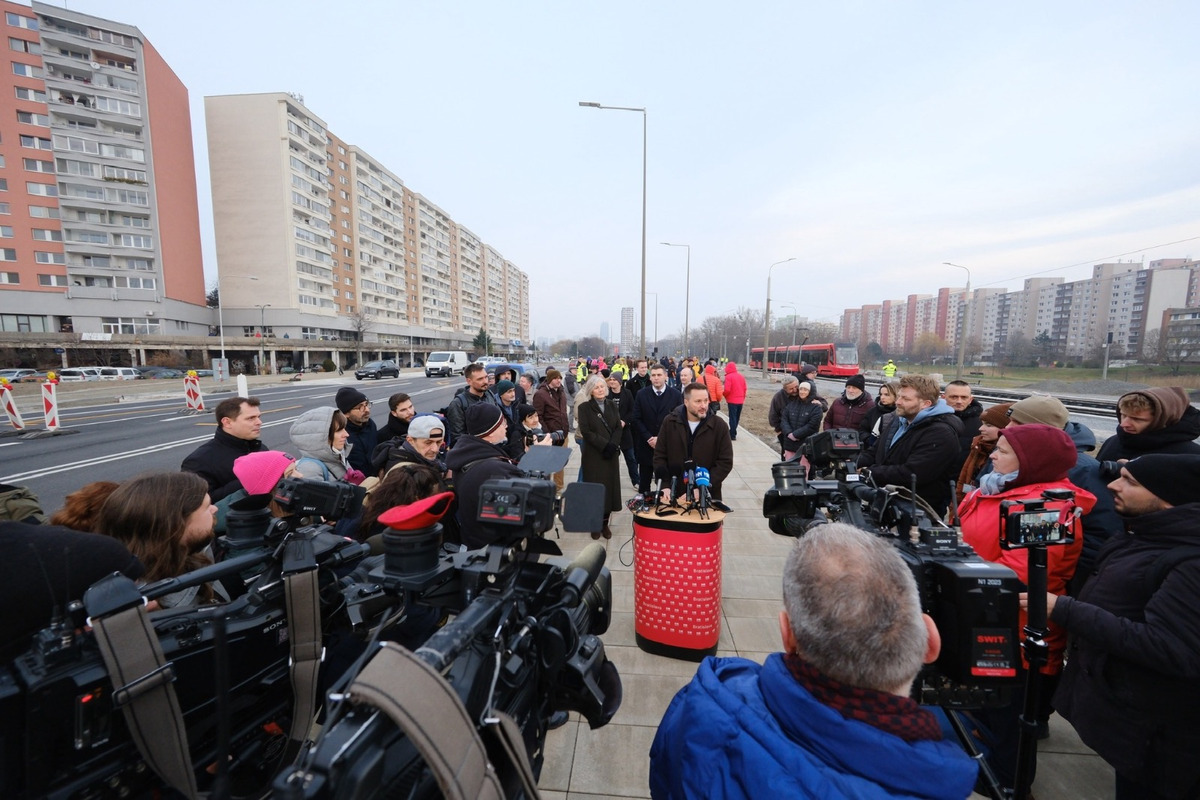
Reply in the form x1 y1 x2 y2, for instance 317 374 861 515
654 384 733 500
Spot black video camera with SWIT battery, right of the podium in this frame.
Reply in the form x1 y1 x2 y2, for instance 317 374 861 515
762 431 1021 708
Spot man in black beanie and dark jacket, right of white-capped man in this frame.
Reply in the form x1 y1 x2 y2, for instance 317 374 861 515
446 403 522 549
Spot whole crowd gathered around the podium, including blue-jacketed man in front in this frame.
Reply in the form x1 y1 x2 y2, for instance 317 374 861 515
0 359 1200 800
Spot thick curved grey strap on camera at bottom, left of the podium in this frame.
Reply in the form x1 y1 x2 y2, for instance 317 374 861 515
348 643 540 800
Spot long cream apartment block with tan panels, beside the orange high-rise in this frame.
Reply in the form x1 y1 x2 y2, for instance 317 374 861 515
204 92 529 351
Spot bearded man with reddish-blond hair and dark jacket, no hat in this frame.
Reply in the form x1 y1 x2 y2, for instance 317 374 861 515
858 375 962 515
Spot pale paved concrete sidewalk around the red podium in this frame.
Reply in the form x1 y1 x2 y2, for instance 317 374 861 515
539 428 1114 800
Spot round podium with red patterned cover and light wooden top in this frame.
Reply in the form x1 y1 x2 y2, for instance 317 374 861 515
634 511 725 661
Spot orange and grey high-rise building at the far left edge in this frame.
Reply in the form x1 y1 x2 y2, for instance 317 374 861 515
0 0 211 336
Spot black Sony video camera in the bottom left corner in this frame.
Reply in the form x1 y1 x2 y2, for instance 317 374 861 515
0 481 368 798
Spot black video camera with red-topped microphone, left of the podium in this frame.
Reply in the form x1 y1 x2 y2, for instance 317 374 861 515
275 447 620 798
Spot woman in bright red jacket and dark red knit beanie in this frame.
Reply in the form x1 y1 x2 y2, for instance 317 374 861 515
959 425 1096 787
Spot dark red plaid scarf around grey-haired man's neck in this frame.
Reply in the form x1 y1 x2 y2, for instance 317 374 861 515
784 652 942 742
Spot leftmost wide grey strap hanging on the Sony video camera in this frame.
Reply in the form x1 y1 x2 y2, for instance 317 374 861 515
90 604 199 798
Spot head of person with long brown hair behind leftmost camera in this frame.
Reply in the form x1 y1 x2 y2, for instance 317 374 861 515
96 473 217 608
